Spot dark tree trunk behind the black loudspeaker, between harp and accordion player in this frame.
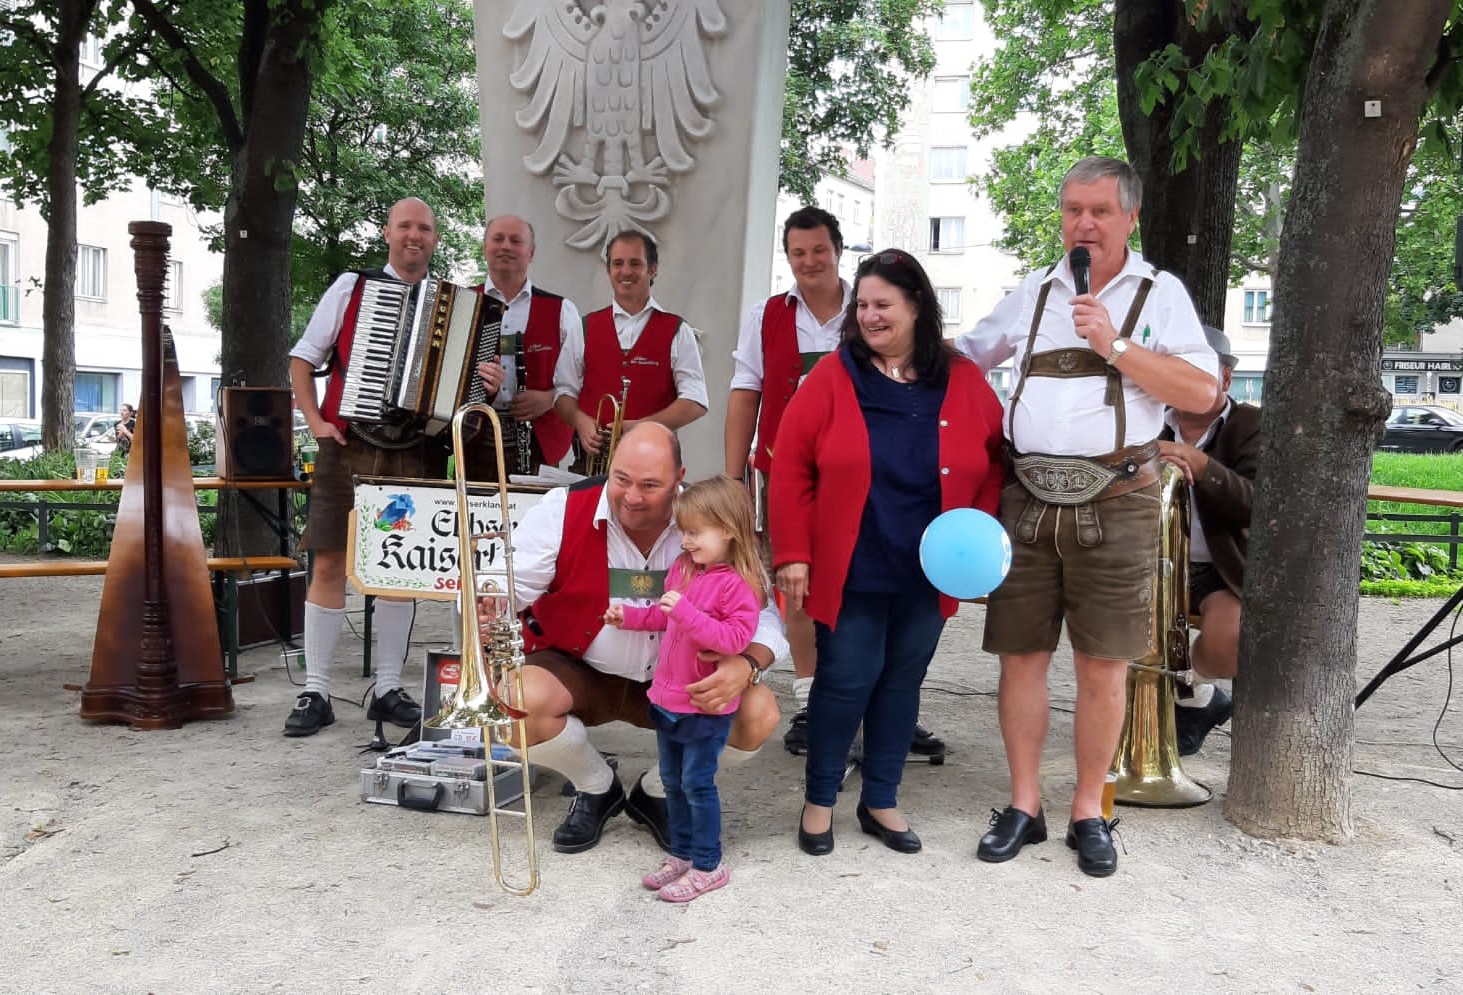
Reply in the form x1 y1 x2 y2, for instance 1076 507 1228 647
215 0 328 555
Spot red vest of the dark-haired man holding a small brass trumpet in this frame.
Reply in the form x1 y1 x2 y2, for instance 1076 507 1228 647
579 307 680 427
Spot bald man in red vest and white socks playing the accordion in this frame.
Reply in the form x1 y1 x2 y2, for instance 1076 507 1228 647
284 198 446 736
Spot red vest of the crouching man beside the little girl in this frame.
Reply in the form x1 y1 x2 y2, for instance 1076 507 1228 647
524 477 608 657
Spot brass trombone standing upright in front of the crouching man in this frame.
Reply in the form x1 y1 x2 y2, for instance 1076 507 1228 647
426 404 538 896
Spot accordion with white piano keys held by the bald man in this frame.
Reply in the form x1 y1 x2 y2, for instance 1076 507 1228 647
339 277 503 436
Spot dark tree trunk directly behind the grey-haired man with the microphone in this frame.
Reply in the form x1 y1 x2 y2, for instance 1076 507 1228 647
1113 0 1242 328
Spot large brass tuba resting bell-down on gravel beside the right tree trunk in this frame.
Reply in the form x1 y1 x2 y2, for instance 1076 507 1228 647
1112 465 1214 808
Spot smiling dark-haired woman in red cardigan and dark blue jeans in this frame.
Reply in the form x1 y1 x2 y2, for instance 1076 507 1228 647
768 249 1004 856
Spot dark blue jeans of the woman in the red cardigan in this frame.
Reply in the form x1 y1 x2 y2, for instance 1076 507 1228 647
803 585 945 809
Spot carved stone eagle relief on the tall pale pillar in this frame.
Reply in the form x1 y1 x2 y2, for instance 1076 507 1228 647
503 0 727 252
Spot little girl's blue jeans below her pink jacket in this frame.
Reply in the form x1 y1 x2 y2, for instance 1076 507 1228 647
651 705 732 871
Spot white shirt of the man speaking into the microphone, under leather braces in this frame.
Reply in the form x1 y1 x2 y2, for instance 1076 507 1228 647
955 249 1219 457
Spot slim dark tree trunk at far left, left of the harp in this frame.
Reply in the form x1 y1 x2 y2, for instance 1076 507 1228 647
41 0 91 449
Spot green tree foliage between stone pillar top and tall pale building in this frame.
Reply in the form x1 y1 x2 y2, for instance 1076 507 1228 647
780 0 944 200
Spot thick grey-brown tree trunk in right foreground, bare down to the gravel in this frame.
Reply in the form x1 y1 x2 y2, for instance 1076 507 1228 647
1225 0 1451 841
